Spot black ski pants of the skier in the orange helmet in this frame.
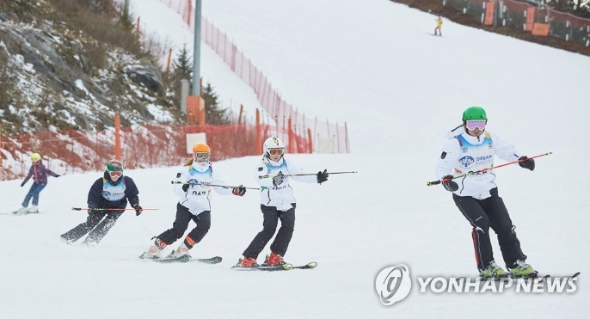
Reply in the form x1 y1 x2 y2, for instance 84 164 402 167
158 203 211 249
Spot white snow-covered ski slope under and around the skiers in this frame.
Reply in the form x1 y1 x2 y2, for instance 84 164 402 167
0 0 590 319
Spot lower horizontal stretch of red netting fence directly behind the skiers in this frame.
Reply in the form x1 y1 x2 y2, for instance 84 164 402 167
0 119 311 180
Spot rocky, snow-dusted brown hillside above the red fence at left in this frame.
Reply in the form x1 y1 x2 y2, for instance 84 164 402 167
0 0 181 136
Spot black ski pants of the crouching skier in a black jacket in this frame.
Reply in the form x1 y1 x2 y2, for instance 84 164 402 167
61 210 123 244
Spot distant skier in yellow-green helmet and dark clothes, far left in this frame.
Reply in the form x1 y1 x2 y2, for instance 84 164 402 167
14 153 60 215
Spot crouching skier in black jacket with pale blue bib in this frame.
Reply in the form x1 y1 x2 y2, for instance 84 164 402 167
61 160 143 245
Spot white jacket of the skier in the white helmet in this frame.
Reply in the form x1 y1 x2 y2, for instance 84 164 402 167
255 156 317 211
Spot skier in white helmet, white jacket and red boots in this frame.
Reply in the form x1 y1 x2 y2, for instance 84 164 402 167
236 137 328 267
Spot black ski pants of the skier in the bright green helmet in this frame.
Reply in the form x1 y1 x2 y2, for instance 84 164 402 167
453 188 526 271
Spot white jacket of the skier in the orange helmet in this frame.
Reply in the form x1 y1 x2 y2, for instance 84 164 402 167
172 163 232 215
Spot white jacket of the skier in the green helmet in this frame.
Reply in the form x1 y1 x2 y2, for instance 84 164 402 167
435 126 520 199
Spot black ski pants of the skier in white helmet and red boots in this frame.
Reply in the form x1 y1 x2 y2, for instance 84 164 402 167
243 204 295 259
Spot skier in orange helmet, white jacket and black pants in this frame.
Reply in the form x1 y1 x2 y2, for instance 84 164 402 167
139 143 246 259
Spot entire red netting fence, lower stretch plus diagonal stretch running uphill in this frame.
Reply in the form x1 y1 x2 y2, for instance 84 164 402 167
0 0 349 180
